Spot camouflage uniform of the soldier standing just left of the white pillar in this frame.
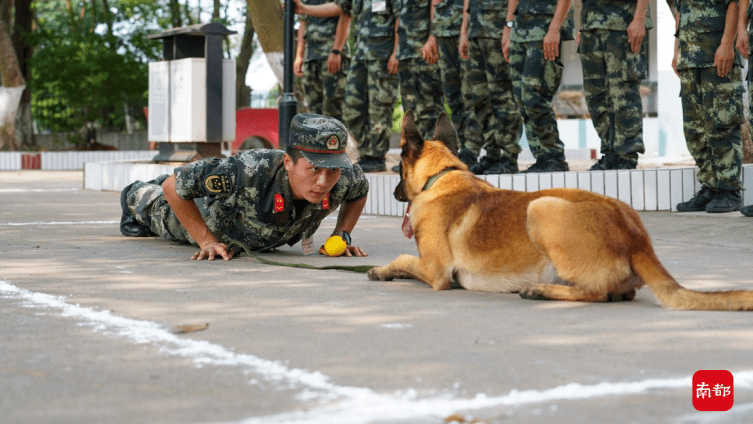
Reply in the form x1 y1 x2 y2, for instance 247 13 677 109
578 0 653 169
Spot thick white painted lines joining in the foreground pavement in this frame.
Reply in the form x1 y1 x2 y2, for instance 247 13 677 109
0 280 753 424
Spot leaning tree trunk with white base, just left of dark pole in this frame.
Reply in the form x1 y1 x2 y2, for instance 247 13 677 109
247 0 285 86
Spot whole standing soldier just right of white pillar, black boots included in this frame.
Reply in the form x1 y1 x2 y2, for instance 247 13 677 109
673 0 745 212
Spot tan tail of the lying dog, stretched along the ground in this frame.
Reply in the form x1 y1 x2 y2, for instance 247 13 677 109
632 251 753 311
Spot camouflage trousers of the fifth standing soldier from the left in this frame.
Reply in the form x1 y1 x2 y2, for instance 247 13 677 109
479 38 523 163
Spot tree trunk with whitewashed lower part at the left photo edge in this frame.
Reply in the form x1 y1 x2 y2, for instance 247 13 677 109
0 0 26 150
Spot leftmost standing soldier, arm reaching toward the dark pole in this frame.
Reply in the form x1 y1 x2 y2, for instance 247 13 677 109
293 0 350 121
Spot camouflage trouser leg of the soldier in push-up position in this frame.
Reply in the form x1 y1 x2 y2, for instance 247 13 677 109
124 175 196 245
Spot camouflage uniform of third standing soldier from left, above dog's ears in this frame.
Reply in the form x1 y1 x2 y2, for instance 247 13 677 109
394 0 444 140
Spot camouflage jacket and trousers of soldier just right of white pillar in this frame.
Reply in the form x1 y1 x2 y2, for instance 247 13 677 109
675 0 744 192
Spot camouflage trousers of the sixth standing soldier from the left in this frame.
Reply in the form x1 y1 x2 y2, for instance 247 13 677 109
510 41 565 161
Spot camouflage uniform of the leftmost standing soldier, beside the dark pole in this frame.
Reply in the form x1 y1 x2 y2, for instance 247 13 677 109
301 0 350 121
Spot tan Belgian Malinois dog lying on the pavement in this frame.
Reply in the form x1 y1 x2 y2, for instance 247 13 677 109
368 111 753 310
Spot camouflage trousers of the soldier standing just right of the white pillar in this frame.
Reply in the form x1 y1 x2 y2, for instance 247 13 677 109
680 67 744 190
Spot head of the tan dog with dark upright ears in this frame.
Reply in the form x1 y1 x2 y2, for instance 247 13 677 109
394 110 468 202
